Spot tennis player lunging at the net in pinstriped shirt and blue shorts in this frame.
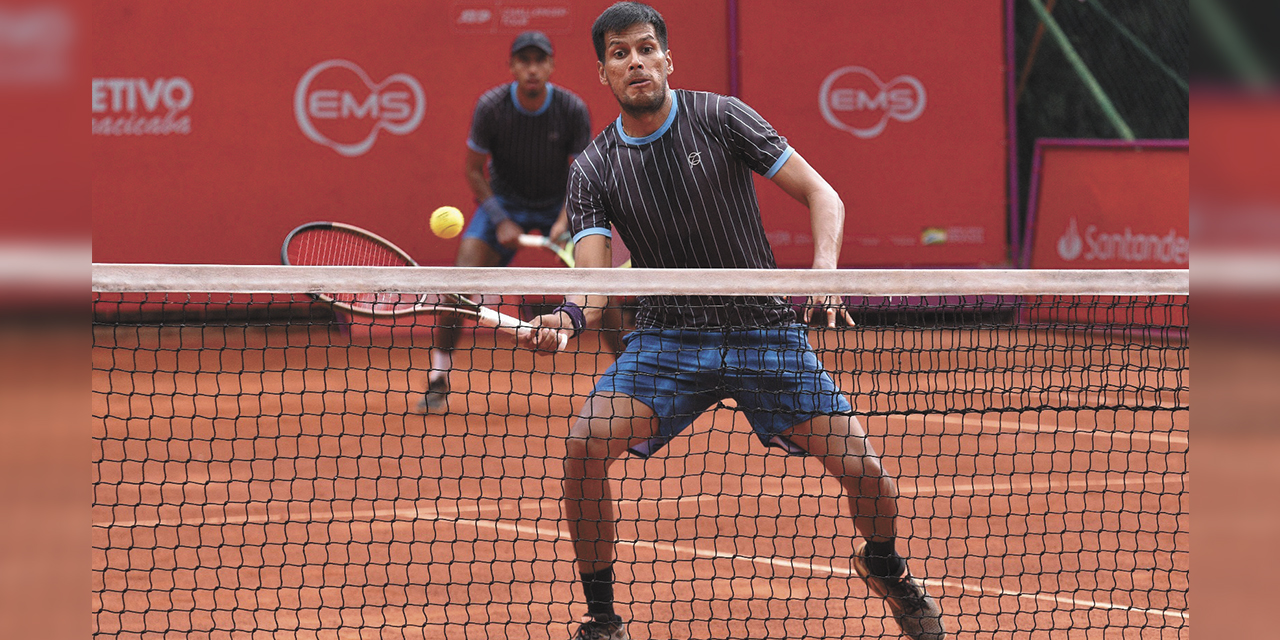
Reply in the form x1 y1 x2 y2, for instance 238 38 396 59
521 3 946 640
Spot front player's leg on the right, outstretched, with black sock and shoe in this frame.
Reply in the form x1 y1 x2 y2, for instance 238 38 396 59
787 416 946 640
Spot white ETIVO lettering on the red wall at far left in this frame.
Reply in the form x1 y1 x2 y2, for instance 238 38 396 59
92 77 195 136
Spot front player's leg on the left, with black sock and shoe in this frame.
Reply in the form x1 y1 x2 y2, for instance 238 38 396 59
564 396 658 640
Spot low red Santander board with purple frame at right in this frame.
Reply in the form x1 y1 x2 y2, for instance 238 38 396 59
1024 141 1190 269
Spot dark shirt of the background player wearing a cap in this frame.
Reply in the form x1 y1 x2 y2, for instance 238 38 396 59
467 82 591 209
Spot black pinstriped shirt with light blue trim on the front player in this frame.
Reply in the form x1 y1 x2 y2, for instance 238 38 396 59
568 90 795 329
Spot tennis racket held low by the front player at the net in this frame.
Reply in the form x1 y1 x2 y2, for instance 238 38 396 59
280 221 568 348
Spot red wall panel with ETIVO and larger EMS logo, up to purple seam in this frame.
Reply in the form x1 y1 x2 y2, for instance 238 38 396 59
87 0 728 265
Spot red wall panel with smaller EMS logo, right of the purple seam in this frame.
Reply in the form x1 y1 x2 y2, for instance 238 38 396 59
742 0 1009 268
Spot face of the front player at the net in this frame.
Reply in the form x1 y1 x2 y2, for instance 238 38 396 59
599 24 672 114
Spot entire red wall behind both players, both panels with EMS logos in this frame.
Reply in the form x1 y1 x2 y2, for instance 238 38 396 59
90 0 1007 266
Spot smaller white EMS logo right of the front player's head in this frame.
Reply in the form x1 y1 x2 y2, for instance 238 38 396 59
818 67 925 140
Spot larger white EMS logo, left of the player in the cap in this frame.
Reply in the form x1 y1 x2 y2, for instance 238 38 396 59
293 59 426 157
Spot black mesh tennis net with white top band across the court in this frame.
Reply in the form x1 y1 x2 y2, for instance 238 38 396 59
92 265 1190 640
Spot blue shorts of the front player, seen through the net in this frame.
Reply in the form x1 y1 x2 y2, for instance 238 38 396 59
593 325 852 457
